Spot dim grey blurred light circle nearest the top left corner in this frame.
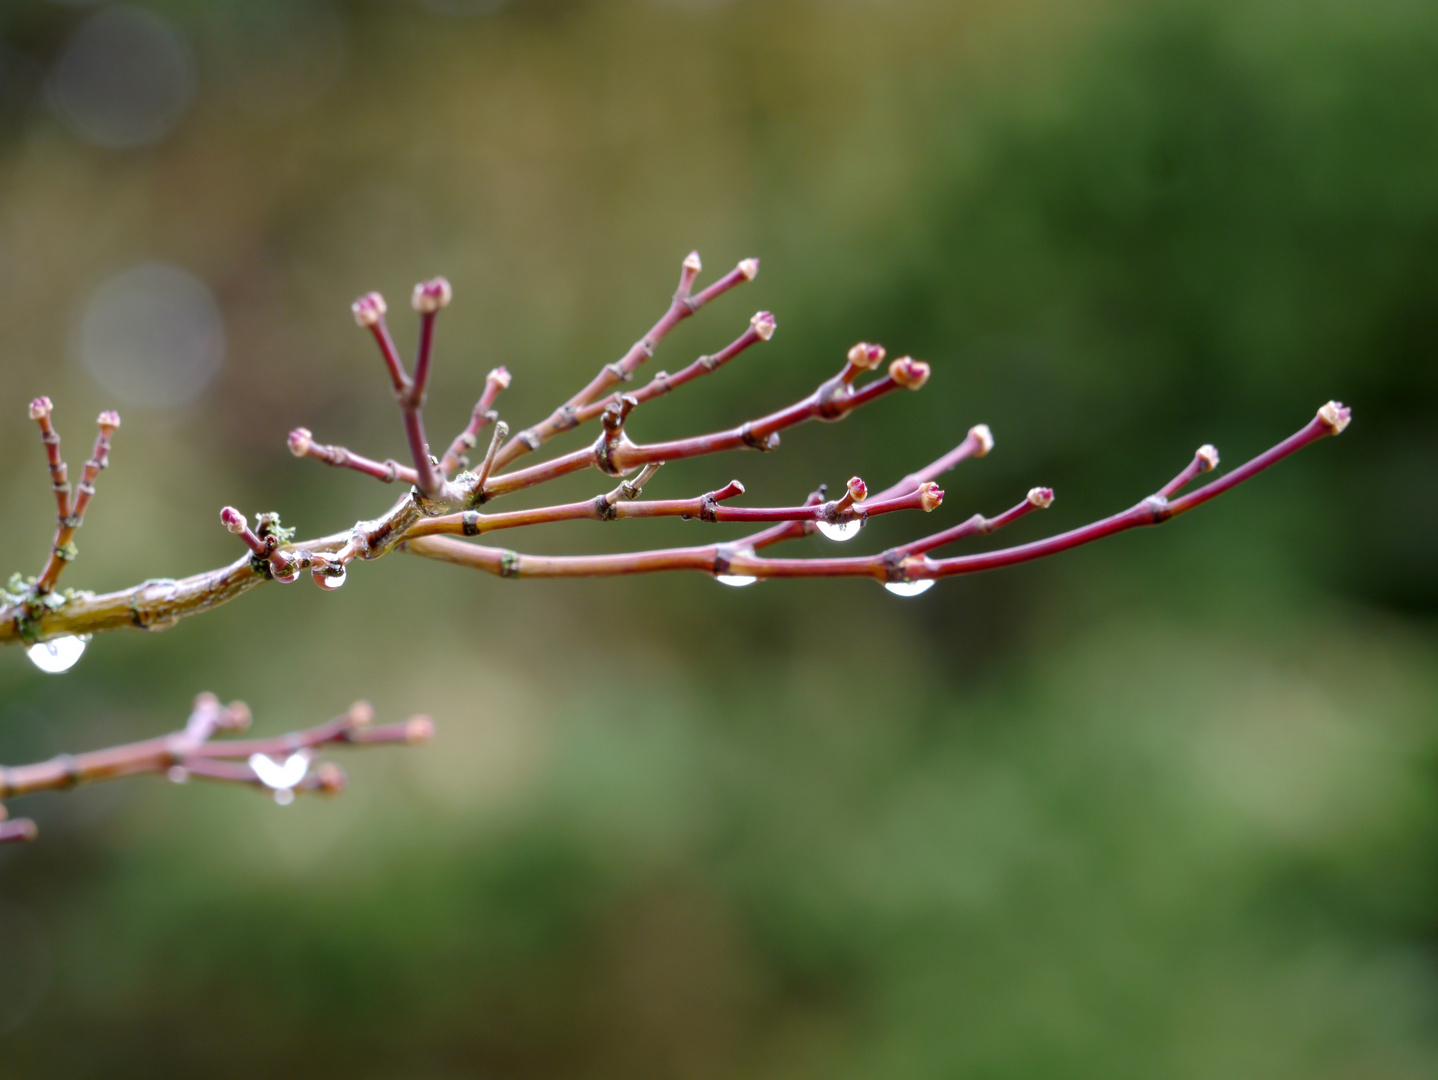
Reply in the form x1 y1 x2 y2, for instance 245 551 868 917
46 7 194 147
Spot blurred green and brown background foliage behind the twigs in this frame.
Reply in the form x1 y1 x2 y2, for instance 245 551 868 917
0 0 1438 1080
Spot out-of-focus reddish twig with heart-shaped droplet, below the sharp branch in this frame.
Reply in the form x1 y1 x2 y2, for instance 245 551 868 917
0 693 434 843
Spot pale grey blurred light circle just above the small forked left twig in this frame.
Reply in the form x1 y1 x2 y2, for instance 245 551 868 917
76 263 224 408
